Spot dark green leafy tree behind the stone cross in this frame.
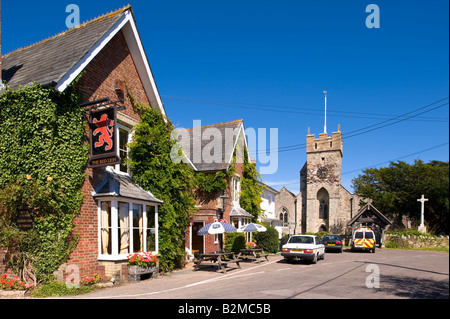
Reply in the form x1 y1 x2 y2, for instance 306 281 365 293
353 160 449 234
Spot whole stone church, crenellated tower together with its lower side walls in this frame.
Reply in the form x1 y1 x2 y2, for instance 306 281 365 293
275 127 362 235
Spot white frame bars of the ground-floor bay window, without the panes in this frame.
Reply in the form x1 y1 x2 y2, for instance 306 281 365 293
97 197 159 261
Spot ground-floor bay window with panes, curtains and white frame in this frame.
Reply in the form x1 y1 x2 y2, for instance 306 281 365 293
99 200 158 260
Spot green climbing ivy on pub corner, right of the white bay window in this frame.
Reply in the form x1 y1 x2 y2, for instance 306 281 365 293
128 106 196 271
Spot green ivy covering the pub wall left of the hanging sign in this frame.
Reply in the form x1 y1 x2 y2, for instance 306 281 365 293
0 85 89 281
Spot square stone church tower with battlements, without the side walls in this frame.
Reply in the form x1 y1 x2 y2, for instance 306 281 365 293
300 127 343 233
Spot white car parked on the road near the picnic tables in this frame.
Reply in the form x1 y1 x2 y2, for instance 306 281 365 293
281 235 325 264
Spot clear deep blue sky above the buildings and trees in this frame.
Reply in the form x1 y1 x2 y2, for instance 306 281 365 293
2 0 449 193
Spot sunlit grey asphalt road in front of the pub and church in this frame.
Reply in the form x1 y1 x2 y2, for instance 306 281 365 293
68 249 449 305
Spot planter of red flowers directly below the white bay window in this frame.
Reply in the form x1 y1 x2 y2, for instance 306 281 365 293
127 252 159 282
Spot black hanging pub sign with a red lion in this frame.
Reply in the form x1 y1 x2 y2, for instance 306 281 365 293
88 107 121 168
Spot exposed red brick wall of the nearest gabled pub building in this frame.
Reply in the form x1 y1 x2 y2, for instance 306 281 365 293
63 31 149 277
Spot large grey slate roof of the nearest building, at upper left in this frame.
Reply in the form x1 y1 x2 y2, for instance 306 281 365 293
2 6 131 90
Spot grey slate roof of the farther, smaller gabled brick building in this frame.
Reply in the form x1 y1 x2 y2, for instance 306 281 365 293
180 120 245 171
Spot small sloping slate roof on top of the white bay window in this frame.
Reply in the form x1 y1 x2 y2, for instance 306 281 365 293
92 168 163 204
